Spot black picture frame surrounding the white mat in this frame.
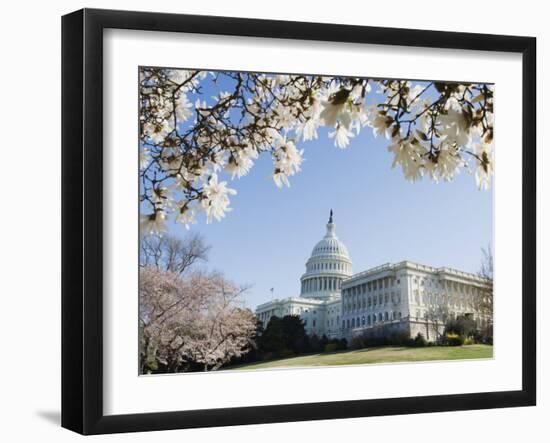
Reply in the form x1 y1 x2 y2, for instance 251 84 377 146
62 9 536 434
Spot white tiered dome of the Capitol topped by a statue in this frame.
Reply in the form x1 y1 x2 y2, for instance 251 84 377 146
300 210 352 300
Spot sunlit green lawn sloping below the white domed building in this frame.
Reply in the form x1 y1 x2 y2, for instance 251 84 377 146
227 345 493 370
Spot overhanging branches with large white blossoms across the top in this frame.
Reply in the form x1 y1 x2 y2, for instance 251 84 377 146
139 67 494 234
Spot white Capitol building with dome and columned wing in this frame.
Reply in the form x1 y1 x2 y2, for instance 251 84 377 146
256 211 492 341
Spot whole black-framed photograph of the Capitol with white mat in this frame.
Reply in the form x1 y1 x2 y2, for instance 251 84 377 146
62 9 536 434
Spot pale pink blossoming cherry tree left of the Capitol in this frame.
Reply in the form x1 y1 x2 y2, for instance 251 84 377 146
139 266 256 373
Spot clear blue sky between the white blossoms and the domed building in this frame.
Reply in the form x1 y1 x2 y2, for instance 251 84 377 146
165 124 493 308
